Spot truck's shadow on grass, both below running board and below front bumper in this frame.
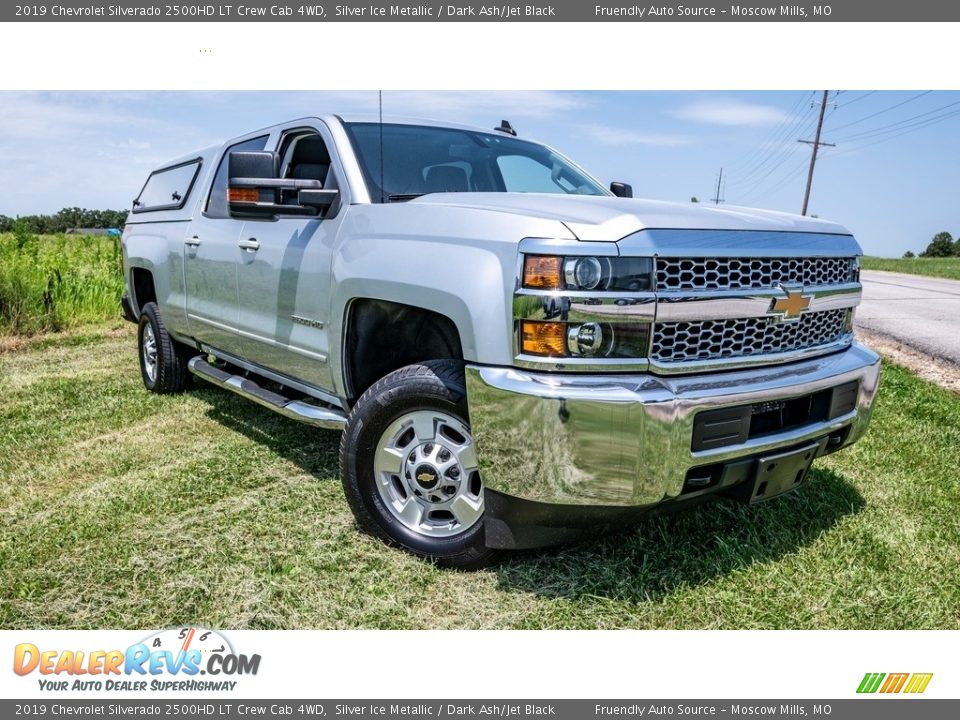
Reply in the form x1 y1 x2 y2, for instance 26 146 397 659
197 386 865 602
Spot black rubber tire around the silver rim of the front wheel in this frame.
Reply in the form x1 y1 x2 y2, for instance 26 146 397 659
340 360 495 570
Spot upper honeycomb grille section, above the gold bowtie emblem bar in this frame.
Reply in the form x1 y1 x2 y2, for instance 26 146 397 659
656 257 857 291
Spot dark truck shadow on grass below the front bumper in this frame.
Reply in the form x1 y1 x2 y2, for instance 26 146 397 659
498 468 866 602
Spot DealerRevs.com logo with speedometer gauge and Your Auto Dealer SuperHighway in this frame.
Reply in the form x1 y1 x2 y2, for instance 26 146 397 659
13 627 260 692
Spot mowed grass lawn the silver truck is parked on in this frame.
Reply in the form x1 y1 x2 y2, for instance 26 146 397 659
0 326 960 629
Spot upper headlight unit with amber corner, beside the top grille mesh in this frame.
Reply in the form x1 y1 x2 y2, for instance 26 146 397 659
523 255 653 292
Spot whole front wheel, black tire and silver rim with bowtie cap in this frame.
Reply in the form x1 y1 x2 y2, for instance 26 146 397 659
340 360 494 569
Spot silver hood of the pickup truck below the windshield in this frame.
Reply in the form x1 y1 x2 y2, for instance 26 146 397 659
410 193 850 242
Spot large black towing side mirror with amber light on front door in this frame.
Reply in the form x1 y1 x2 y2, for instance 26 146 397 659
227 152 339 218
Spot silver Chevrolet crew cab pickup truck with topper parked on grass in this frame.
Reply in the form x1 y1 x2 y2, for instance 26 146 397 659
123 115 880 567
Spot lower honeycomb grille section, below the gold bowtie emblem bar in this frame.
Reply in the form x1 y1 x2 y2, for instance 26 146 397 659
650 309 851 363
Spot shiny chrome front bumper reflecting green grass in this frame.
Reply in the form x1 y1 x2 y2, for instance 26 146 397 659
467 344 880 507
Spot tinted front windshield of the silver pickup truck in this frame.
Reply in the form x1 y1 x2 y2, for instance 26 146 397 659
345 123 609 202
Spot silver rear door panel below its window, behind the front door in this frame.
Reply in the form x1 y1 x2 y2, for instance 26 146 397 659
183 218 242 353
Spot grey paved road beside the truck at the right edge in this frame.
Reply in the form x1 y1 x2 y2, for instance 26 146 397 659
856 270 960 364
